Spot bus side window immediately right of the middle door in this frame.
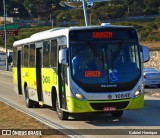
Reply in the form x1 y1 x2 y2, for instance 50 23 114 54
43 41 50 67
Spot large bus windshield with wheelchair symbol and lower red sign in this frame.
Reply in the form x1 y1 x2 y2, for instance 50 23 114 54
70 42 141 88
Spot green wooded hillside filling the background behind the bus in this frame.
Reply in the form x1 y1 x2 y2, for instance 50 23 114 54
0 0 160 49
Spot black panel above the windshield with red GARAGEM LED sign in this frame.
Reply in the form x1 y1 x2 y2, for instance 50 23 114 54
69 27 138 41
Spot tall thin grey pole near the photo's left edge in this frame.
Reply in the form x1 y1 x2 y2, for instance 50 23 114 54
3 0 9 71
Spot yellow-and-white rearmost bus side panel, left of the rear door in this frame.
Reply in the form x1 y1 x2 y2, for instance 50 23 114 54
12 67 19 94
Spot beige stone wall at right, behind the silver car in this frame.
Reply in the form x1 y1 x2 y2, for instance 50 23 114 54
144 51 160 71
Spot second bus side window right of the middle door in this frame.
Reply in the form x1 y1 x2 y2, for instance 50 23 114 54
50 40 57 67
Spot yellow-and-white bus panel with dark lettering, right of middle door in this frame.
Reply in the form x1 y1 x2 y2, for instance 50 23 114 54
42 68 58 106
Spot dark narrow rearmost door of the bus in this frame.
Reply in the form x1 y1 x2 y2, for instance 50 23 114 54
17 51 22 94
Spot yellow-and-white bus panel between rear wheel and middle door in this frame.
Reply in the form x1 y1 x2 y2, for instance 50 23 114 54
28 68 38 101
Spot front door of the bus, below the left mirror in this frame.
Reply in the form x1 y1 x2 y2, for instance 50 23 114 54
58 48 67 109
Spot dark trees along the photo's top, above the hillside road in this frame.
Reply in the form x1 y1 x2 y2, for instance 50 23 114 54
0 0 160 20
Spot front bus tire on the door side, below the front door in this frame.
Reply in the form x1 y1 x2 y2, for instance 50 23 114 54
56 98 69 120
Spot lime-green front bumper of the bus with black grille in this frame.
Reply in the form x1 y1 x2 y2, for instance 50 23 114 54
67 94 144 113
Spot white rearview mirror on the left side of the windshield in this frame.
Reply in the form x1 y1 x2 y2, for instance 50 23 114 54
59 48 68 65
